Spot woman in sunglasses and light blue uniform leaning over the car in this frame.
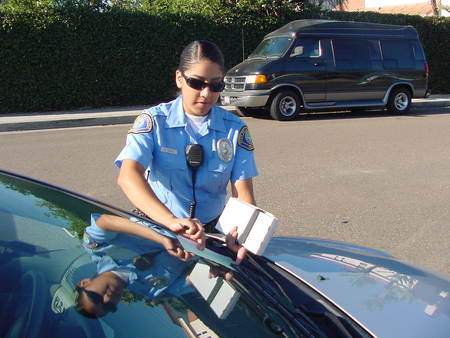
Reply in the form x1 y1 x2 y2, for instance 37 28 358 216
115 41 258 256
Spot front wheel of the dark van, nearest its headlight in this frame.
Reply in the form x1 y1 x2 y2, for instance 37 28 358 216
270 90 301 121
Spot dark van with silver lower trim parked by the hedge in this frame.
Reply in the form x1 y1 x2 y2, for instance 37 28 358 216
221 20 428 120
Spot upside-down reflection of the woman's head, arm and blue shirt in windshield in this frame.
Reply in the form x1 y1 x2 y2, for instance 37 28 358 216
76 214 196 317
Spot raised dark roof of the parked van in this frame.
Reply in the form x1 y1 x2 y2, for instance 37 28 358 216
265 19 418 39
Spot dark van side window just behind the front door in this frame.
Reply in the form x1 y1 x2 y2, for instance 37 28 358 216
333 39 370 70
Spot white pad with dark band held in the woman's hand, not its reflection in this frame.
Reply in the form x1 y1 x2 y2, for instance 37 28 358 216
216 197 278 255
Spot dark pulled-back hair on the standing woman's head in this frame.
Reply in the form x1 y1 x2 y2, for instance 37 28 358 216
178 40 225 73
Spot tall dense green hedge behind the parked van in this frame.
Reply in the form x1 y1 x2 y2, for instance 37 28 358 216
0 7 450 112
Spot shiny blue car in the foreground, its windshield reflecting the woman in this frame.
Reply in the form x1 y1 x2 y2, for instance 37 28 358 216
0 171 450 338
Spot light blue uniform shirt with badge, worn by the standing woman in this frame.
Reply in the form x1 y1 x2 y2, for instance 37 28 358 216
115 96 258 223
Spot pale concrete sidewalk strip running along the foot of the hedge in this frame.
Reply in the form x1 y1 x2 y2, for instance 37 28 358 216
0 95 450 132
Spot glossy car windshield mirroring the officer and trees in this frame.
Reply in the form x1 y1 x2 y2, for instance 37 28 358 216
0 171 316 338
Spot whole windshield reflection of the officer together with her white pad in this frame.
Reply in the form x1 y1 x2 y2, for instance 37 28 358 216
75 214 296 337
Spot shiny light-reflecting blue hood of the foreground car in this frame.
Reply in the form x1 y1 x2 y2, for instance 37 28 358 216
264 237 450 337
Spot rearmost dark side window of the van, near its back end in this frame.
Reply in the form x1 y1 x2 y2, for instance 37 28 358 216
381 40 415 69
